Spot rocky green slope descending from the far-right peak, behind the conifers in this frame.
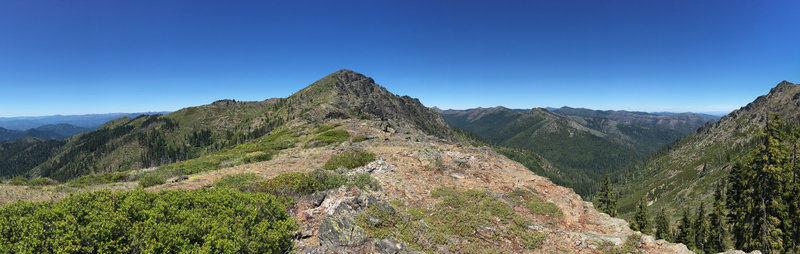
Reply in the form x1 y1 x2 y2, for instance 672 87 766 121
616 81 800 227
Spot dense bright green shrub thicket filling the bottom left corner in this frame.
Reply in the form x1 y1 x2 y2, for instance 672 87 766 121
0 189 297 253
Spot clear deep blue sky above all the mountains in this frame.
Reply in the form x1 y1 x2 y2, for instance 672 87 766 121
0 0 800 116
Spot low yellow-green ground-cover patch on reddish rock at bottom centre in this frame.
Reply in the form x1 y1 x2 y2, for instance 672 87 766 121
357 187 561 253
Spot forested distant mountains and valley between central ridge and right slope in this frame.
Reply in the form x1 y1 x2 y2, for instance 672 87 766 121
439 107 718 195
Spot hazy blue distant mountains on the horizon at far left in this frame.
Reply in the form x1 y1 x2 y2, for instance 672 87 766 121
0 111 169 131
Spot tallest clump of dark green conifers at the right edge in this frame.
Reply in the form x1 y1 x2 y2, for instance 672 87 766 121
724 115 800 253
